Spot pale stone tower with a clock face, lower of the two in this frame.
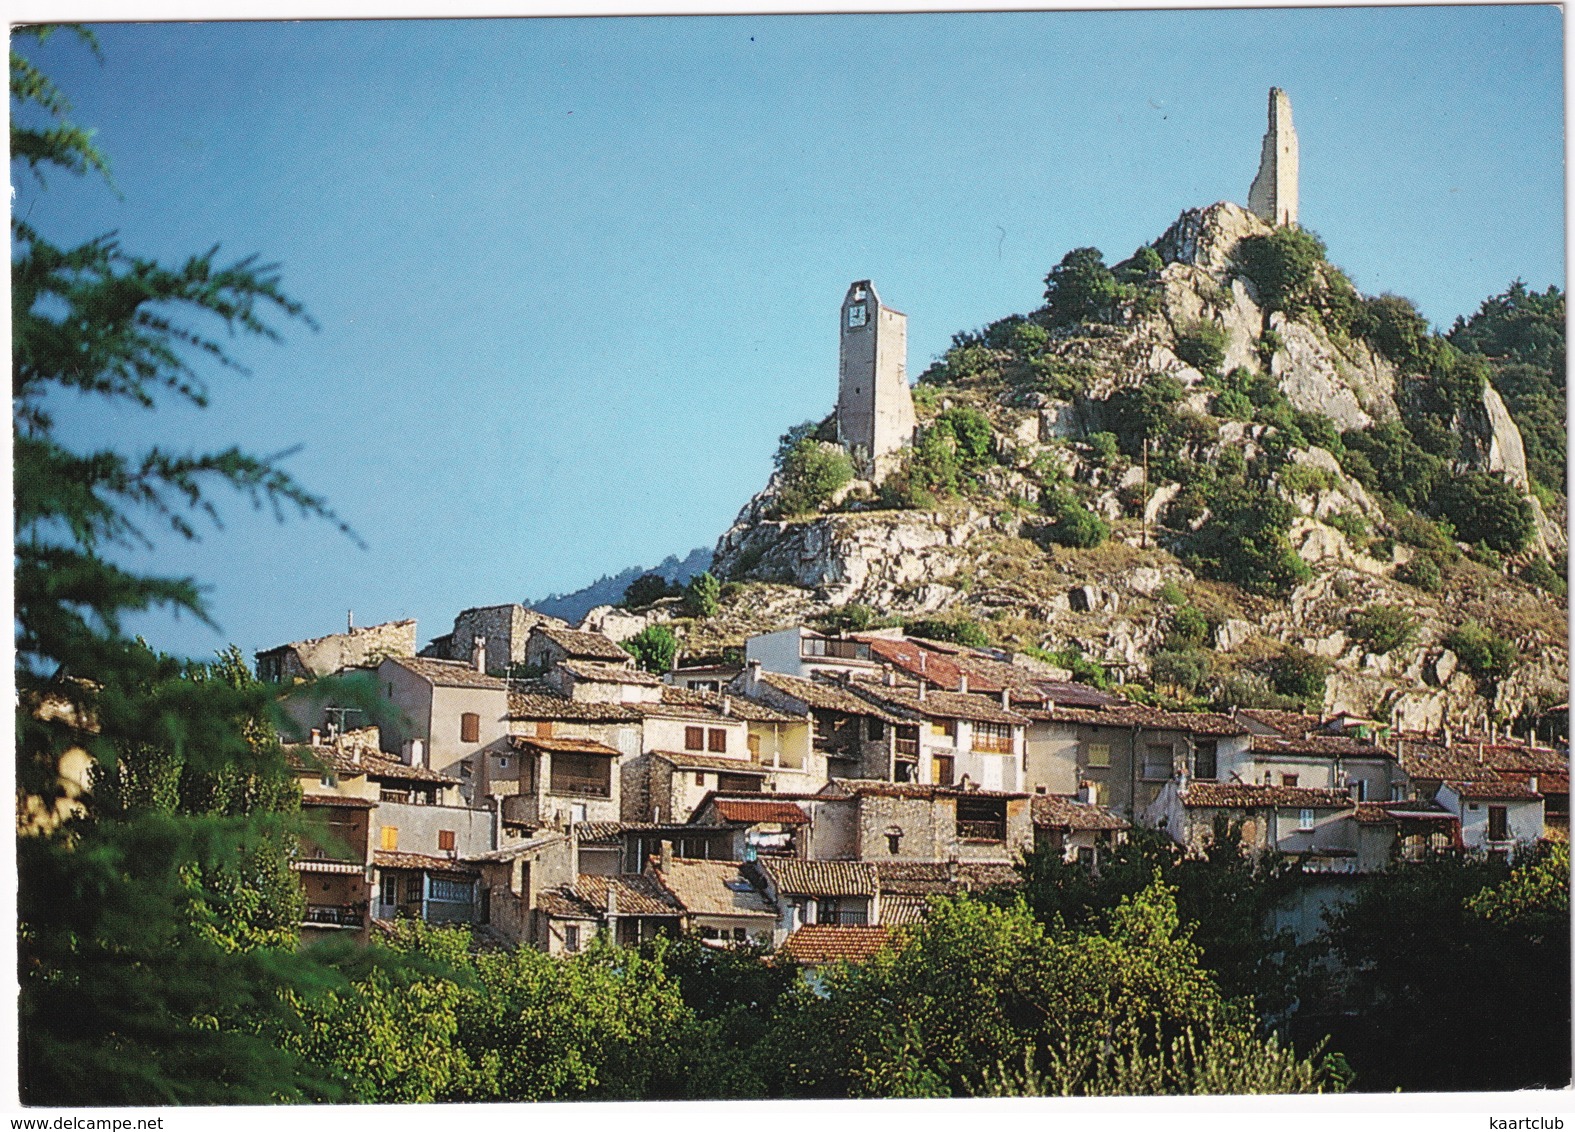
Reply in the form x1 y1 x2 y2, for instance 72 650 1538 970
836 279 917 479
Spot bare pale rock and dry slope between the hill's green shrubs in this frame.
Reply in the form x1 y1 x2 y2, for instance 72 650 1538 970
699 203 1567 726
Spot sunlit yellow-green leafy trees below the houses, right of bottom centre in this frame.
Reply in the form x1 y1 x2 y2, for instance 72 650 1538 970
769 883 1321 1097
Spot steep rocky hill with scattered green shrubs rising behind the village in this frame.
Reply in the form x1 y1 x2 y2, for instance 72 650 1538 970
654 203 1569 727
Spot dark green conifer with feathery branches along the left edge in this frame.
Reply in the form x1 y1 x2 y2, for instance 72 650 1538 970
11 37 357 1107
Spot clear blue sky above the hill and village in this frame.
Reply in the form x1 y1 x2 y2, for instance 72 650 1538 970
14 6 1564 657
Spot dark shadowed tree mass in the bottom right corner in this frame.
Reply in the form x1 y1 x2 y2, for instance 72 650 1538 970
1299 850 1570 1091
